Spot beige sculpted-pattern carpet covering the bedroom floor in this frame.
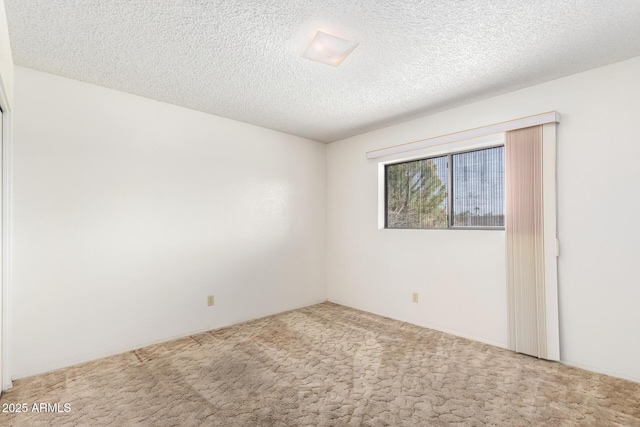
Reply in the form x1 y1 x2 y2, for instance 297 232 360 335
0 303 640 426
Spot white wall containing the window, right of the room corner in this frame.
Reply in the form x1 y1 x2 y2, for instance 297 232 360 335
327 58 640 381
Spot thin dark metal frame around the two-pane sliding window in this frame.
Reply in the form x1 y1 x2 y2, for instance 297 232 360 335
382 142 506 231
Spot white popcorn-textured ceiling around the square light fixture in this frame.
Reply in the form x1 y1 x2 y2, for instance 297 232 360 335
4 0 640 142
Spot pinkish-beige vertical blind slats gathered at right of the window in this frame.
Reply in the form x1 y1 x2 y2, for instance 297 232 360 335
505 125 547 358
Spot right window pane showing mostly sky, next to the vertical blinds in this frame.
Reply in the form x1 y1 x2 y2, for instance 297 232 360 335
453 147 504 227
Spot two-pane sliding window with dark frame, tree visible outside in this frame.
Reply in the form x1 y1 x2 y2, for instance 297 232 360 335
385 147 504 229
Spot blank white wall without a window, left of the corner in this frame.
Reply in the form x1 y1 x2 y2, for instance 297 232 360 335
12 67 326 379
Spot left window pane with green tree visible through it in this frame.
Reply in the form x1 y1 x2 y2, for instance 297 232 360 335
385 157 447 228
